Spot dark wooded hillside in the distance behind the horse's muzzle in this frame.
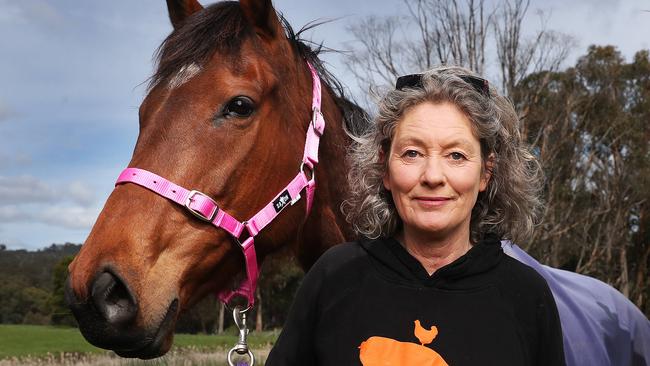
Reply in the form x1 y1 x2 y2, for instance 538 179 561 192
0 243 303 333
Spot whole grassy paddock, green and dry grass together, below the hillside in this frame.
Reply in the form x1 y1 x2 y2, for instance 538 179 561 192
0 325 278 366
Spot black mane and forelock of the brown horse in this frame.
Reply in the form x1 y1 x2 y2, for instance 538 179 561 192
149 1 368 136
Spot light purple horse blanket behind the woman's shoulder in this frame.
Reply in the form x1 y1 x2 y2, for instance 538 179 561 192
502 241 650 366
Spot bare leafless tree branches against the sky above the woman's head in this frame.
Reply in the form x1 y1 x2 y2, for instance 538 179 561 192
345 0 575 106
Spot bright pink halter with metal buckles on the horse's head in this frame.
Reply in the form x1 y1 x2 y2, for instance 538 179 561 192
115 62 325 307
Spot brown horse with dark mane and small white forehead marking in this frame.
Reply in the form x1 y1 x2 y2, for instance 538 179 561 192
66 0 363 358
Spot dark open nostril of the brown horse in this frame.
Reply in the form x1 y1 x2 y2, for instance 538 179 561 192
91 272 137 325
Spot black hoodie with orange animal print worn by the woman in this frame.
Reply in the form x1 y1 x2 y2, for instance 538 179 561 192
266 237 565 366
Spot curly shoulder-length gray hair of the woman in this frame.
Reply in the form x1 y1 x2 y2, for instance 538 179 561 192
342 66 543 243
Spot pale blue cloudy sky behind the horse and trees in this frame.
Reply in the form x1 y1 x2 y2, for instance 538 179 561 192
0 0 650 249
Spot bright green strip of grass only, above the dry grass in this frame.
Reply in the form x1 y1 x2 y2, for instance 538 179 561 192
0 325 278 360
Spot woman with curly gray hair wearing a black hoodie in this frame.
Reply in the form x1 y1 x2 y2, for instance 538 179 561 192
267 67 565 366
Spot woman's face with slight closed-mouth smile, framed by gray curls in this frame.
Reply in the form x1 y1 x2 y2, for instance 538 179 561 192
384 102 489 242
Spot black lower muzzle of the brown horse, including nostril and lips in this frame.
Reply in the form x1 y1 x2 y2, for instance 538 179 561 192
65 272 178 359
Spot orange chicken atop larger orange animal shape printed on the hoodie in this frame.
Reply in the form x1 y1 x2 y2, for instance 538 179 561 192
359 320 448 366
